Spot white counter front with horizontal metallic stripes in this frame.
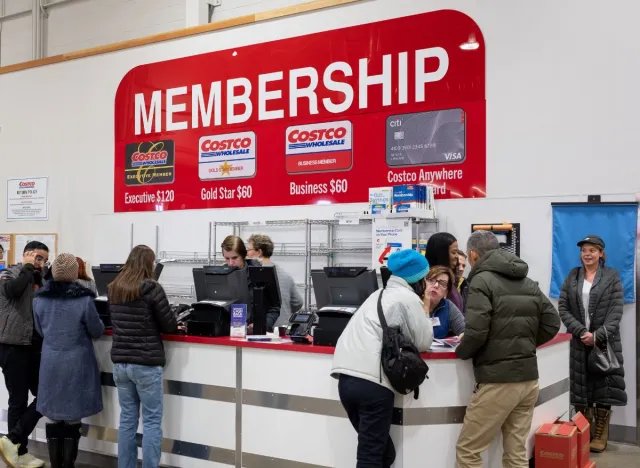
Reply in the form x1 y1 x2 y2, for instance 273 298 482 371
0 337 569 468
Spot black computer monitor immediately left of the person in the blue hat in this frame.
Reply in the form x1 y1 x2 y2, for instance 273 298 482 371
311 267 378 310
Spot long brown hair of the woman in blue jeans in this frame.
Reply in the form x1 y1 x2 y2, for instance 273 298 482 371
108 245 156 304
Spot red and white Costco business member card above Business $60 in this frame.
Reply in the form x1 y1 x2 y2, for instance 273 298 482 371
285 120 353 174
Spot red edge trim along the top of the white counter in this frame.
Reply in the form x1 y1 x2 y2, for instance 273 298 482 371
105 330 571 360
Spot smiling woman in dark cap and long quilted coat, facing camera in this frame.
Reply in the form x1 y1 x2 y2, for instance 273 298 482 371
558 235 627 452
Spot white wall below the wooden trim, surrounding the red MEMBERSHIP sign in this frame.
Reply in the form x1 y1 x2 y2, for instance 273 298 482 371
0 0 640 436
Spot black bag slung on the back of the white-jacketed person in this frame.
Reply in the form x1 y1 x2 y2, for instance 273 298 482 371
378 289 429 400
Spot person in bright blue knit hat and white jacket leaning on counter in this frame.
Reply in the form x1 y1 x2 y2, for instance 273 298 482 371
331 249 433 468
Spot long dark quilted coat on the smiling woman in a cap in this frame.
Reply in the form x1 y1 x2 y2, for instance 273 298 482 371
558 267 627 406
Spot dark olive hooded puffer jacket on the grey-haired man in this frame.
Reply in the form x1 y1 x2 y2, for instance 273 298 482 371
456 249 560 383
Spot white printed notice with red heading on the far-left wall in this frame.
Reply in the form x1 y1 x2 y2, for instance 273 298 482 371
7 177 49 221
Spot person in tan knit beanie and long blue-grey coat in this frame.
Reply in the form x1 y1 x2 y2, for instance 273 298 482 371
33 253 104 468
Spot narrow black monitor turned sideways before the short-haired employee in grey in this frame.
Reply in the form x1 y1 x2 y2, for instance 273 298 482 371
248 265 282 335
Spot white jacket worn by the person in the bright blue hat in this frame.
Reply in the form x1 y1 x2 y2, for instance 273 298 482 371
331 276 433 392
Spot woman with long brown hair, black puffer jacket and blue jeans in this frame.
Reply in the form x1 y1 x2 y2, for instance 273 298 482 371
108 245 177 468
